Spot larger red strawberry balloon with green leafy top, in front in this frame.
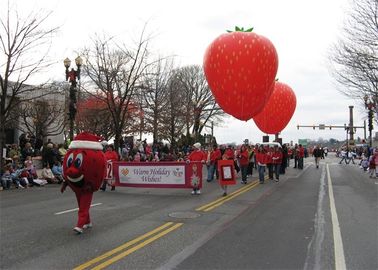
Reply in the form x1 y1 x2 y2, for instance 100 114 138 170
203 27 278 120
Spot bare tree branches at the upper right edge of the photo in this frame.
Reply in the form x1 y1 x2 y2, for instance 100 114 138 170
330 0 378 111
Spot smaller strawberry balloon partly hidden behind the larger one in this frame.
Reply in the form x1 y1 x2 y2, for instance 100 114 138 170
253 82 297 134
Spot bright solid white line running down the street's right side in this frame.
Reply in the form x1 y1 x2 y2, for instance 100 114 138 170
327 164 346 270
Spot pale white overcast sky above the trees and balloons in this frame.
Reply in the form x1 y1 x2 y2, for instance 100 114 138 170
0 0 367 146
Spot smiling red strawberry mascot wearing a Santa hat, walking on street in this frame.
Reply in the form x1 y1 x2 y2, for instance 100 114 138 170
61 132 106 233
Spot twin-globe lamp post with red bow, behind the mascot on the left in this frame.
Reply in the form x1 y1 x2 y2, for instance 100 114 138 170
63 56 83 141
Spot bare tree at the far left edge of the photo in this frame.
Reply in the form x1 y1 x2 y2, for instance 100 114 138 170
0 4 57 169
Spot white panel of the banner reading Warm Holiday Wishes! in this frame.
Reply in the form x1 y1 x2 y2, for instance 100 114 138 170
118 163 185 185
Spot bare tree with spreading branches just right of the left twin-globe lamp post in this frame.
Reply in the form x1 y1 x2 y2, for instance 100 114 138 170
83 29 154 150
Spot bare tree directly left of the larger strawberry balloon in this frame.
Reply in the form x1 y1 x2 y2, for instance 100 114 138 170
176 65 226 140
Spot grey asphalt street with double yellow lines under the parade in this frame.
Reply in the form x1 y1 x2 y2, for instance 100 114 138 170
0 156 378 270
